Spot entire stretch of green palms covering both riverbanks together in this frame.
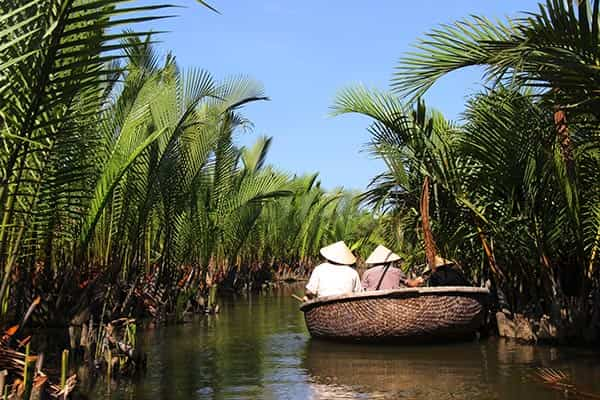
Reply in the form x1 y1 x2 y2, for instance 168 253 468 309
0 0 600 360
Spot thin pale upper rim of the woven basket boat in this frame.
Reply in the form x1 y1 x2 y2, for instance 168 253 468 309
300 286 490 311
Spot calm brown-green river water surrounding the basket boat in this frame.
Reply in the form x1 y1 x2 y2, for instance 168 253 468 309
88 287 600 400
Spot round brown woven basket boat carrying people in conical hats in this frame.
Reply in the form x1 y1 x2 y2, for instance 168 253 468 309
300 286 489 343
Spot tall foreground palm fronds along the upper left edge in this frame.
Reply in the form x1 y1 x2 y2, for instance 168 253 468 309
0 0 195 306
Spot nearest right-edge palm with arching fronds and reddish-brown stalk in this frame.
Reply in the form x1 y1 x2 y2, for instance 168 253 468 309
393 0 600 276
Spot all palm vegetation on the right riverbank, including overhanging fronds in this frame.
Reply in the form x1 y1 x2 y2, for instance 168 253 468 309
334 1 600 340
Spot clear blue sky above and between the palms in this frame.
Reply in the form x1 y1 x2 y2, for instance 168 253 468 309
148 0 537 190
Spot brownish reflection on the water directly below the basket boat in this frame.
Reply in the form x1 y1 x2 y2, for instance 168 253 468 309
306 341 495 399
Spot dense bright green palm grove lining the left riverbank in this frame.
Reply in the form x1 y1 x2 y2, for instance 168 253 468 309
0 0 373 332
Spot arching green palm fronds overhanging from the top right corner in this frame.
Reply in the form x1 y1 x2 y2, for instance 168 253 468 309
393 0 600 118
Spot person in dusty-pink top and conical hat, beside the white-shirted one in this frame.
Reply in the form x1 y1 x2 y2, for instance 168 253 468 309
362 245 423 290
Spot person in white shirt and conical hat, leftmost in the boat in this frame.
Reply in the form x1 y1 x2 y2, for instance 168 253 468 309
304 241 362 300
